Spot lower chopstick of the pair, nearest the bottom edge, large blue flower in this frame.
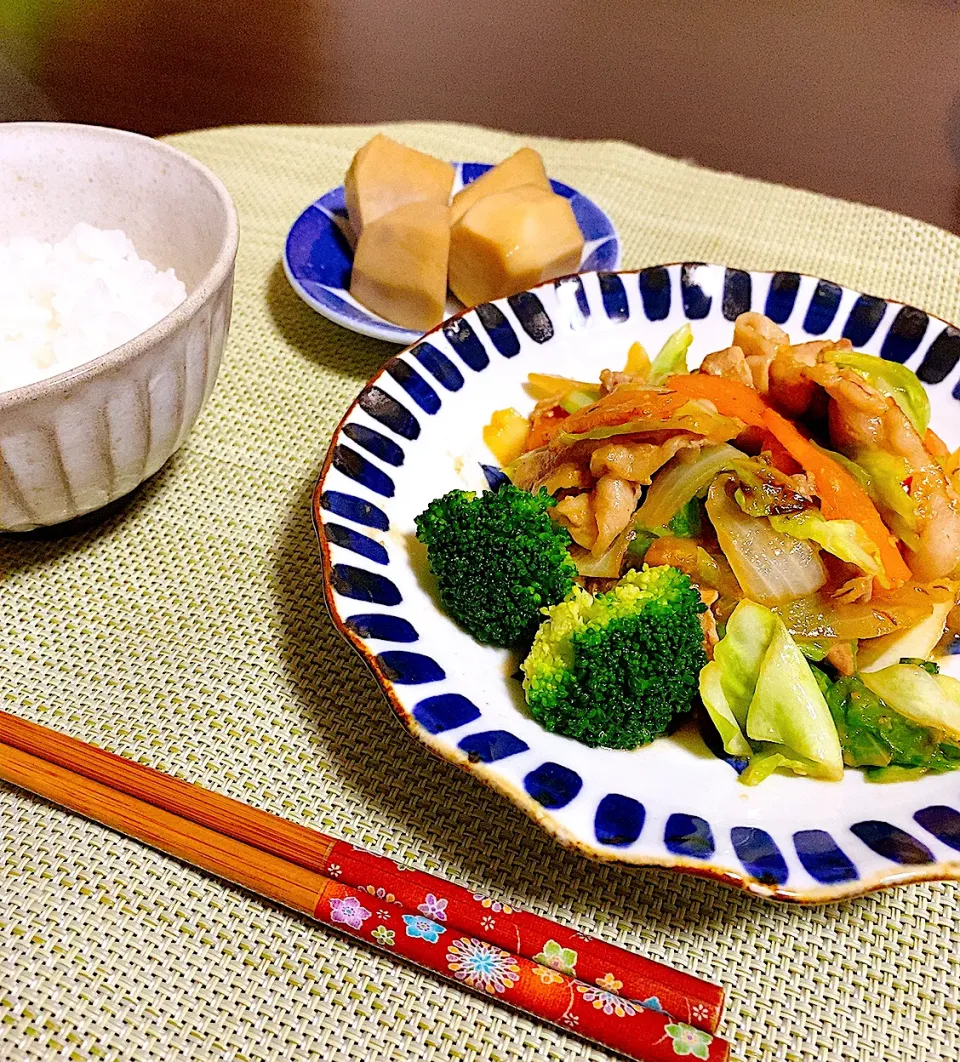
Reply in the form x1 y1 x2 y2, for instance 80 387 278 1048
0 742 730 1062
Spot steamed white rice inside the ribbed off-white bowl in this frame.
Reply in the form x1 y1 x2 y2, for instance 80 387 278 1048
0 224 187 391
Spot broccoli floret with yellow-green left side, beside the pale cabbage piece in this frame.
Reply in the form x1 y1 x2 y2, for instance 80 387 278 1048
524 565 706 749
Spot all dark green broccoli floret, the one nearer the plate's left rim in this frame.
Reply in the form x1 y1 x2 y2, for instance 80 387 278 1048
416 483 577 649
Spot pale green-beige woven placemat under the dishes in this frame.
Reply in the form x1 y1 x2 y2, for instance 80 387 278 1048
0 124 960 1062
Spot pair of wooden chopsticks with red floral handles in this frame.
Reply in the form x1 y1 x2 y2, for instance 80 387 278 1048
0 712 728 1062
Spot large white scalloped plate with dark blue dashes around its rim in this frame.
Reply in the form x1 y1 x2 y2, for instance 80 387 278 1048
314 263 960 903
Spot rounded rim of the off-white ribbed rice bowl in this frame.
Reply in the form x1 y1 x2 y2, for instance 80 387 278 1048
0 122 240 413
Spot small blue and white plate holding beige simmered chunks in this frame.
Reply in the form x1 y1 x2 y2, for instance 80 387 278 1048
284 162 620 346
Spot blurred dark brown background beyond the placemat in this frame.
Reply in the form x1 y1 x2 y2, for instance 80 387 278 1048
0 0 960 232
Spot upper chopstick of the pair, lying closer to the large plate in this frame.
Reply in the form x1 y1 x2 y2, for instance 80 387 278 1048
0 712 723 1032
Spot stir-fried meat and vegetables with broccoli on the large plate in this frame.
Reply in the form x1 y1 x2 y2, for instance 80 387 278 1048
417 313 960 784
